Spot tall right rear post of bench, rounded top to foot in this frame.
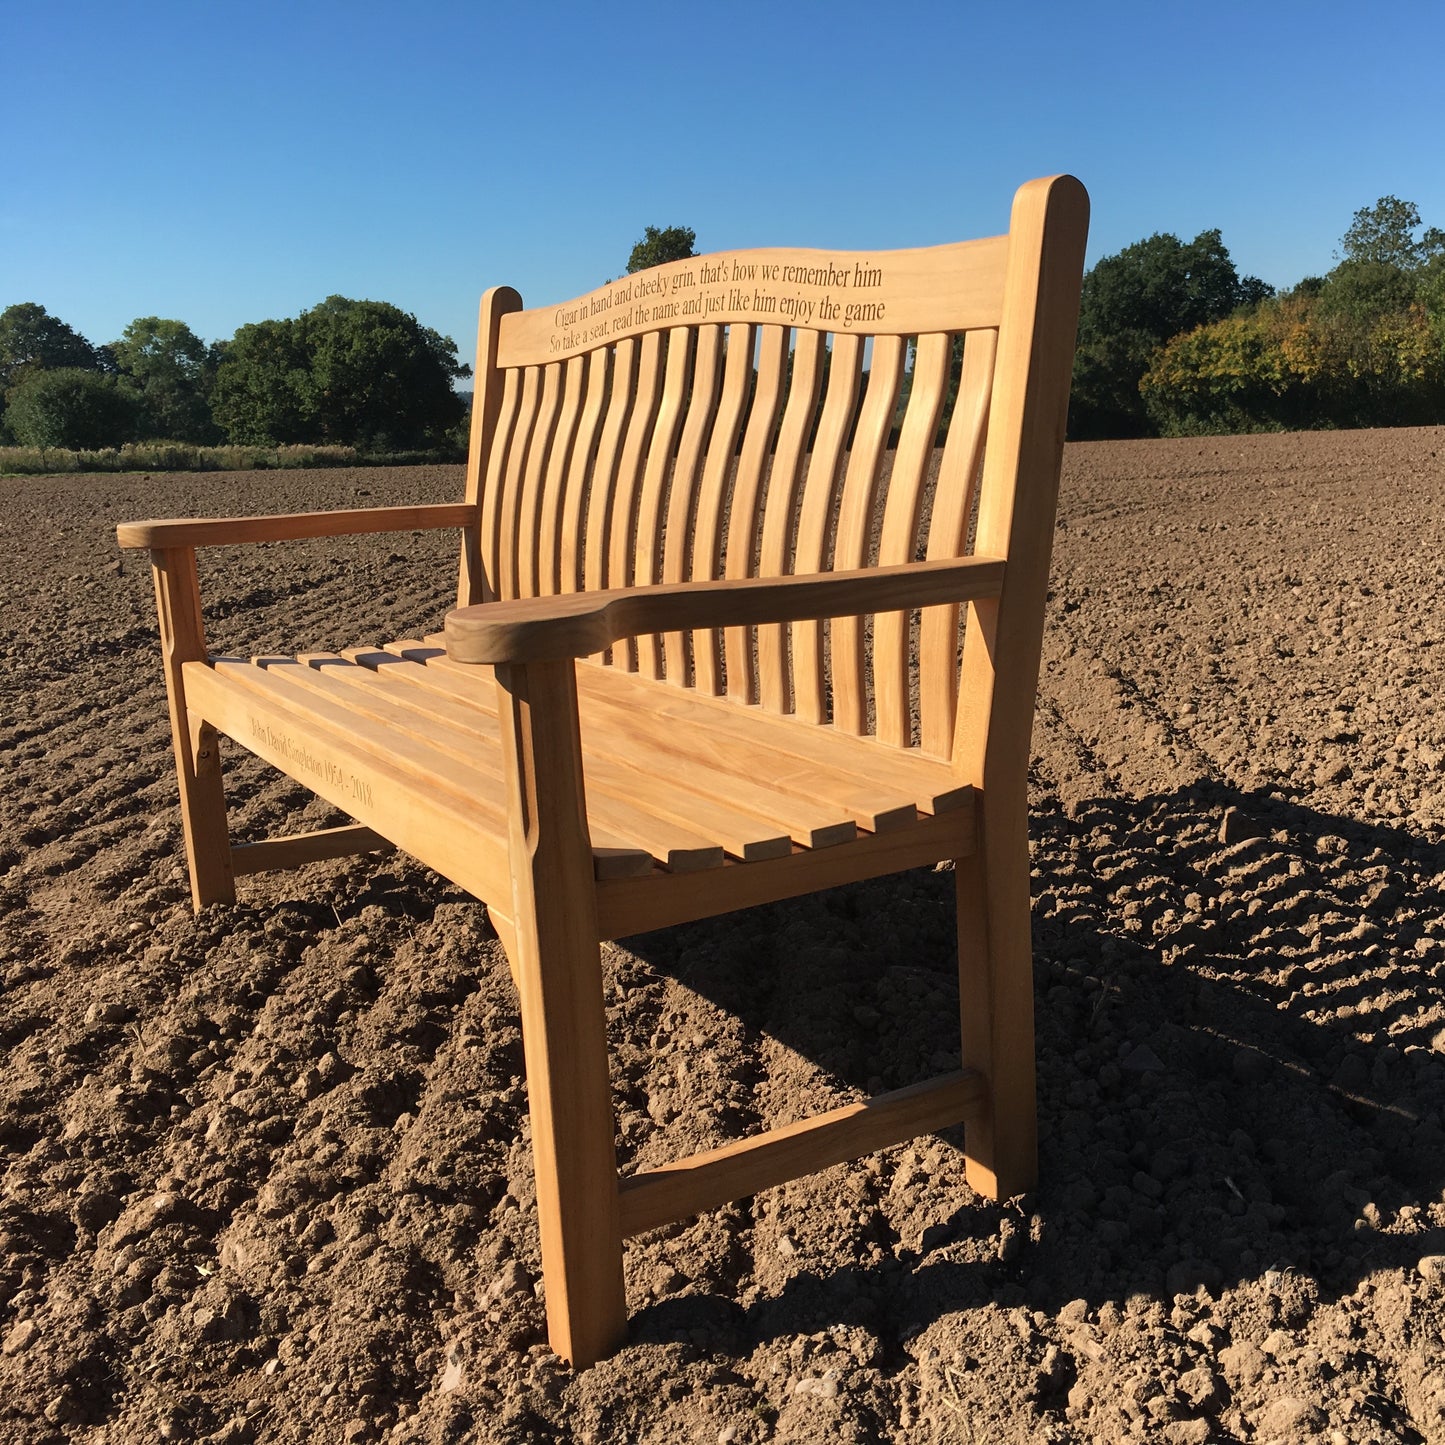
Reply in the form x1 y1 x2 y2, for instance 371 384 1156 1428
954 176 1088 1199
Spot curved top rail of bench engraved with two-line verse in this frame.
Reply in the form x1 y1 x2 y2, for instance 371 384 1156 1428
497 236 1009 367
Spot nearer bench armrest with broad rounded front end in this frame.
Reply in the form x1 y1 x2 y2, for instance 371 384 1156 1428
447 556 1004 663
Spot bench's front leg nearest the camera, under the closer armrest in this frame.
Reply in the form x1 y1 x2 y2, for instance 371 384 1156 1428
497 657 627 1368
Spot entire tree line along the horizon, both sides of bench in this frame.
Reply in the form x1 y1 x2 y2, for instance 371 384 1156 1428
0 195 1445 454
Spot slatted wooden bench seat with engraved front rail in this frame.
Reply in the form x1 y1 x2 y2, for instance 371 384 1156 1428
185 634 974 936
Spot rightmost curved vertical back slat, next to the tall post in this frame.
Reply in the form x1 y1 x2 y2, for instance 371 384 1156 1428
918 331 998 757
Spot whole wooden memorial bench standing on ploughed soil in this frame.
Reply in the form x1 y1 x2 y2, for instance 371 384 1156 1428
120 176 1088 1366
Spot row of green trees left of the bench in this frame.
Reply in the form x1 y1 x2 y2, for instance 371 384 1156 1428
0 296 471 454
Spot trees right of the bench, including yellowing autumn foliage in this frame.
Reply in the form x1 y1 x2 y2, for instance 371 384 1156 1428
1069 195 1445 439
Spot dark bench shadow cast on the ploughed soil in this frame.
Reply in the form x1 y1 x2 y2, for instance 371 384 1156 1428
615 783 1445 1340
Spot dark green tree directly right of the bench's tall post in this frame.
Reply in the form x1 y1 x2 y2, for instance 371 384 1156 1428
1069 230 1270 438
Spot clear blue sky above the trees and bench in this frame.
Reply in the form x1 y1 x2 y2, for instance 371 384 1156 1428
0 0 1445 360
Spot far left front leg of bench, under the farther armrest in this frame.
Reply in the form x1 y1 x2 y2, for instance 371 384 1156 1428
150 548 236 912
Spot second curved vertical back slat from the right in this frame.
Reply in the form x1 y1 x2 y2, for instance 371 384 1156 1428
873 332 951 747
